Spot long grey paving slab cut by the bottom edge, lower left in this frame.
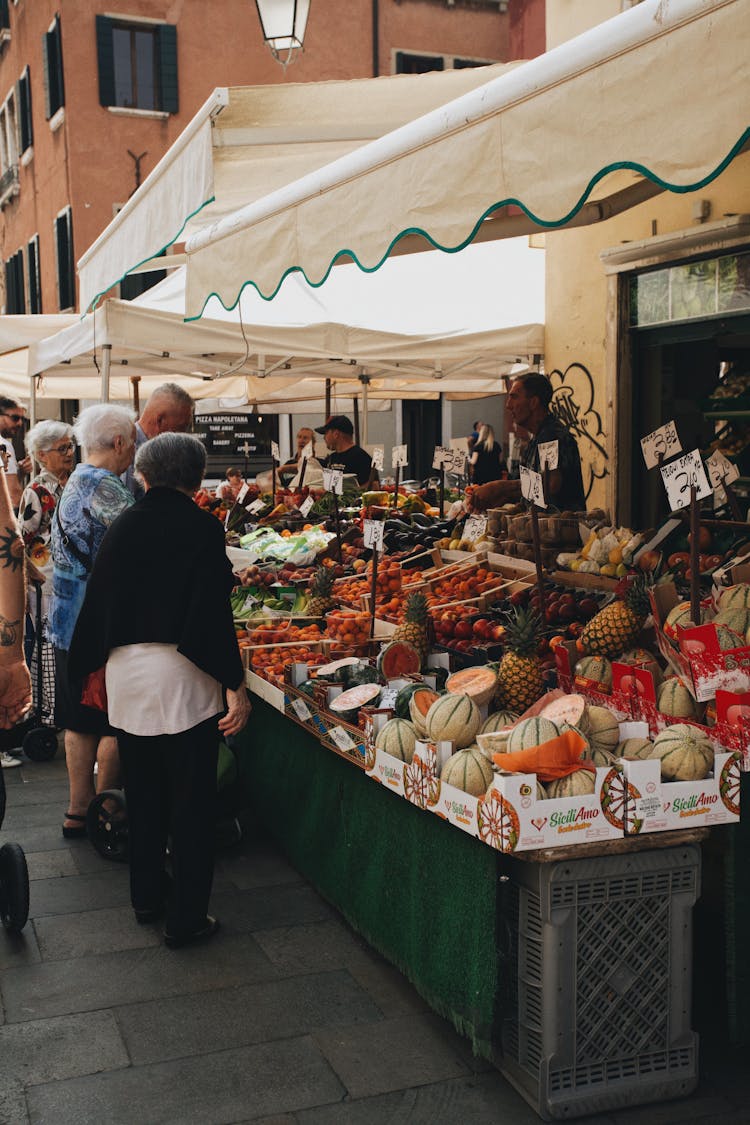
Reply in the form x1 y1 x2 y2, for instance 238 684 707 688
27 1036 346 1125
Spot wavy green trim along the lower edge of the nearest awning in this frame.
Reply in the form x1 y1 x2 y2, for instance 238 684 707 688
186 134 750 322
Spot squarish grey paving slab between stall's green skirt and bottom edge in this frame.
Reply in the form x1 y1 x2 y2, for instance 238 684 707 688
314 1015 468 1098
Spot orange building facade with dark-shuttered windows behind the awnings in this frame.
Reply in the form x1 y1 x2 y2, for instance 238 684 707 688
0 0 544 313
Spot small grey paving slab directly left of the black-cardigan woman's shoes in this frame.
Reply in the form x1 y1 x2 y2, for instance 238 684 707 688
34 906 163 961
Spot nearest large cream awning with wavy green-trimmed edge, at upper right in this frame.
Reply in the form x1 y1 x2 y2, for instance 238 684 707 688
186 0 750 316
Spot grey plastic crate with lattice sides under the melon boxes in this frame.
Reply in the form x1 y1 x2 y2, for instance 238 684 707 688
498 845 701 1121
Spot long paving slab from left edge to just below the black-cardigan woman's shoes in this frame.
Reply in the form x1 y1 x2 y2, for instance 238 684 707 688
1 933 277 1023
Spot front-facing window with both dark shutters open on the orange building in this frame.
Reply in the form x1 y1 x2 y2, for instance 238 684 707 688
97 16 179 114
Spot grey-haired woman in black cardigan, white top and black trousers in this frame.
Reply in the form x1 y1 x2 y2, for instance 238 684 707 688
69 433 250 947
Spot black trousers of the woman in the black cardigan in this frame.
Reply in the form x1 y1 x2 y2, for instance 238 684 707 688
116 714 219 936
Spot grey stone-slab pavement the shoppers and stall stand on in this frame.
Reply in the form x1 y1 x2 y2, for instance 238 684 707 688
0 757 750 1125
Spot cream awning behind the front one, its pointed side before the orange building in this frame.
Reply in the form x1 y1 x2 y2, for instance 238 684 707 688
78 63 517 309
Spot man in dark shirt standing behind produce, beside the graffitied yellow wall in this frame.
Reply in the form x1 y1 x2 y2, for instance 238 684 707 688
470 375 586 512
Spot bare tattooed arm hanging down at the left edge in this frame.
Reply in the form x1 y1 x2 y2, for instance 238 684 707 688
0 469 31 730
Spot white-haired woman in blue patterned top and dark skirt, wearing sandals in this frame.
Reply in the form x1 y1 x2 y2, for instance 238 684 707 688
48 403 135 838
